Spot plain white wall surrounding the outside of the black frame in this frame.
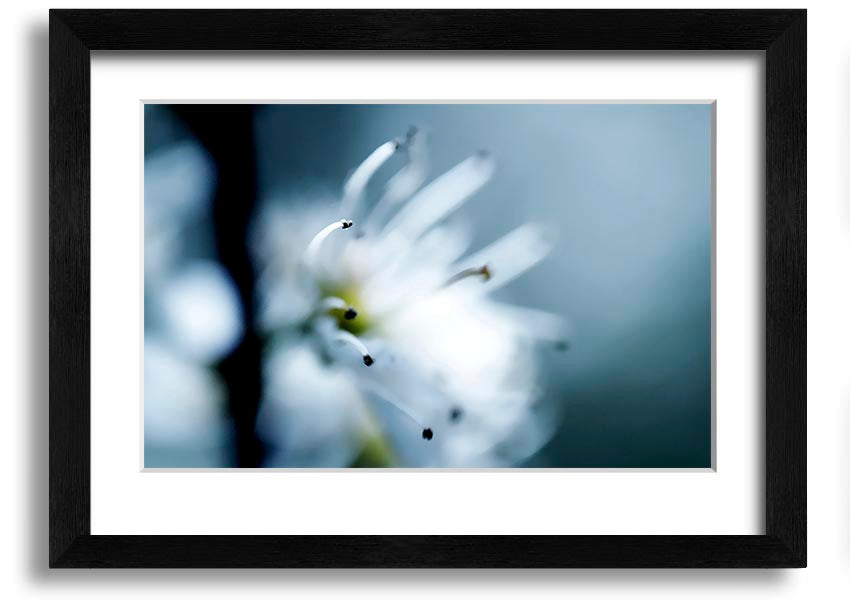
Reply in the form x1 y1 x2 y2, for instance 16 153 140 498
0 0 836 598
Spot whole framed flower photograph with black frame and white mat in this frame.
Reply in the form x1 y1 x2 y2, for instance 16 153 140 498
49 10 806 568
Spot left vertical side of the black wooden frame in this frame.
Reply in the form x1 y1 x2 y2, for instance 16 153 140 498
48 15 91 562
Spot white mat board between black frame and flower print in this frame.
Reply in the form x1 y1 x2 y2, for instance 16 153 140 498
91 53 764 535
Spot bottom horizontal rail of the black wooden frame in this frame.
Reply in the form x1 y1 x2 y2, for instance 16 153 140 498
53 535 788 568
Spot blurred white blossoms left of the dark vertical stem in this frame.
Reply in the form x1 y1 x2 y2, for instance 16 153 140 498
144 132 238 467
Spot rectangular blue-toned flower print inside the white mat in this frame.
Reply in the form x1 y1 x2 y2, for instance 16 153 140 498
143 102 714 469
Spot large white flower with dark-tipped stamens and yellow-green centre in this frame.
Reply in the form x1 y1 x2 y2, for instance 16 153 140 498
255 130 565 467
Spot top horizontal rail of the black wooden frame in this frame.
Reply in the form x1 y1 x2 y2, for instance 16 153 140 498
54 9 799 51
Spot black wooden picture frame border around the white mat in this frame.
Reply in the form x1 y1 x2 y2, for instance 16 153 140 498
49 10 806 567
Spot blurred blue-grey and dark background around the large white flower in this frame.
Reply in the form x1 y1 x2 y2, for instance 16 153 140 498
144 104 712 468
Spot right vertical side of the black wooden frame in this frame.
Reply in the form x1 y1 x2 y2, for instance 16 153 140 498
765 10 806 566
